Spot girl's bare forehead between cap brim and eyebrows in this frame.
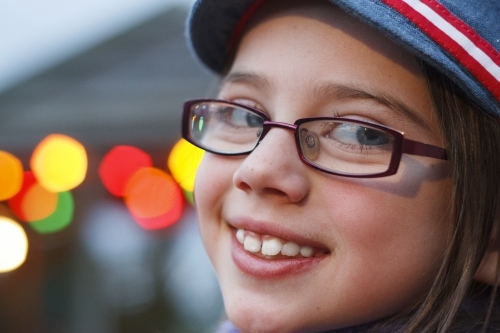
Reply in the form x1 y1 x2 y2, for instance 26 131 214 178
223 1 437 134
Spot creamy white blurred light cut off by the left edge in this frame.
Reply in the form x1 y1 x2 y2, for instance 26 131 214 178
0 216 28 273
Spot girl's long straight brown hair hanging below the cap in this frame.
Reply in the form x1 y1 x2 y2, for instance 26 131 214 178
375 62 500 333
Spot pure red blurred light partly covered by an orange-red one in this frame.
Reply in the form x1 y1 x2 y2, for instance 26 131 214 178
98 146 153 197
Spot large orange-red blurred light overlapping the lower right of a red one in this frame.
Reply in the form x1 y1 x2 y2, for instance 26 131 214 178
125 167 184 230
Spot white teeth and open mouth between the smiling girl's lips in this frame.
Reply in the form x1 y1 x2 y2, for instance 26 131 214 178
236 229 326 259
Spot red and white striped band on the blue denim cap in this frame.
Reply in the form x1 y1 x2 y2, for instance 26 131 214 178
383 0 500 102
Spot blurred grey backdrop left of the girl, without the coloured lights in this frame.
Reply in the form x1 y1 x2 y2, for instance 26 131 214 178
0 0 224 333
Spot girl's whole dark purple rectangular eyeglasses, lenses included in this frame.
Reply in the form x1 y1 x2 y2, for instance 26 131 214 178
182 99 447 178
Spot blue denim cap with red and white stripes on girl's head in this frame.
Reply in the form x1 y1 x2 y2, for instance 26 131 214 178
187 0 500 117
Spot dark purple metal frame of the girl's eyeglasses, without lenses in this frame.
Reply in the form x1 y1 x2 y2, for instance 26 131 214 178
182 99 448 178
